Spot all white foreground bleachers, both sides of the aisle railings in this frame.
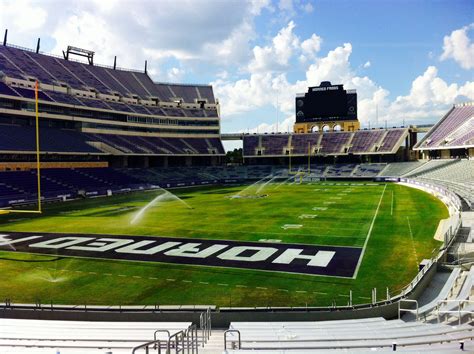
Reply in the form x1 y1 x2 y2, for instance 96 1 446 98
0 317 474 354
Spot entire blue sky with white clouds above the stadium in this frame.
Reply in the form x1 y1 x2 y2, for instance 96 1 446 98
0 0 474 148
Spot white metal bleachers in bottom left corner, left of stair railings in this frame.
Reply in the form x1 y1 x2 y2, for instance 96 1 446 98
0 318 192 354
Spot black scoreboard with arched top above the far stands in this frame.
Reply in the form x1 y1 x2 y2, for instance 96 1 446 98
295 81 357 123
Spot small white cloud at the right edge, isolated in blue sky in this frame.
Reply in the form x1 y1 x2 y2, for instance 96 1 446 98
440 23 474 70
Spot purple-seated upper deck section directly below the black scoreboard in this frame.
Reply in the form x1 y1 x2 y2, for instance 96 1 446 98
243 128 408 157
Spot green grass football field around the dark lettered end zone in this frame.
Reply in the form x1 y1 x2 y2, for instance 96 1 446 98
0 182 448 306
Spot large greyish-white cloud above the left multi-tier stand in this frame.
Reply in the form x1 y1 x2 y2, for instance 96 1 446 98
0 0 271 79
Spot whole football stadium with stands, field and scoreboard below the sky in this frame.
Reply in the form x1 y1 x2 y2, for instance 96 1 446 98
0 8 474 354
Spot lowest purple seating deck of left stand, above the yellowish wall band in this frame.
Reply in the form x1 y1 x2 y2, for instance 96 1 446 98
0 124 225 155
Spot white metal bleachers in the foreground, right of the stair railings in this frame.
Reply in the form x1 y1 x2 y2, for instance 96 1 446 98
227 318 474 353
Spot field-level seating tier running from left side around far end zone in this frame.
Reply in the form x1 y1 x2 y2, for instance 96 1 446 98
0 161 474 208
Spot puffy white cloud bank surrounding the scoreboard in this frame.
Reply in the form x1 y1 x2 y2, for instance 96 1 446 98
213 26 474 132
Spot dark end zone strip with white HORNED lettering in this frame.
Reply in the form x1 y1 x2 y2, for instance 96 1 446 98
0 232 361 277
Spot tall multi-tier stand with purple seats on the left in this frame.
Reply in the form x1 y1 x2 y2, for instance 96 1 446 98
0 41 225 170
